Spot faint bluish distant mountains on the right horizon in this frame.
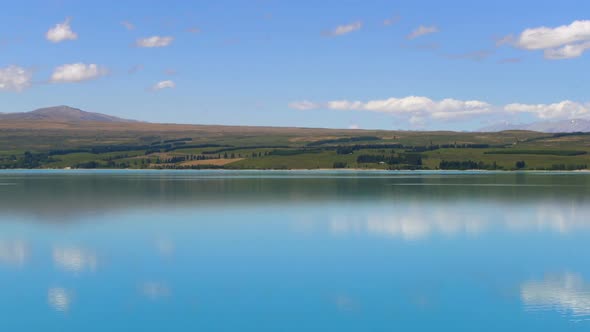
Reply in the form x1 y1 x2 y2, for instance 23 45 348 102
478 119 590 133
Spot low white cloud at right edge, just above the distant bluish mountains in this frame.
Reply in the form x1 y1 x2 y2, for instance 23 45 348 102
504 100 590 120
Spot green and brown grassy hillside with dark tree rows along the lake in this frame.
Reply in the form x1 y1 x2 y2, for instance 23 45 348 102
0 121 590 170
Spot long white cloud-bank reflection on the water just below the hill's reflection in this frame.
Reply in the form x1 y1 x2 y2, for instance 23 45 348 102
329 204 590 240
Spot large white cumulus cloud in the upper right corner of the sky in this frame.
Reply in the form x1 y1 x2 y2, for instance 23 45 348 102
496 20 590 60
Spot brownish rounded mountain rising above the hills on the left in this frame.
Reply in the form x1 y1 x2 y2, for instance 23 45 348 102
0 106 137 122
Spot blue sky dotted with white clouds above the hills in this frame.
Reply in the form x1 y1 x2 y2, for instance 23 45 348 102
0 0 590 130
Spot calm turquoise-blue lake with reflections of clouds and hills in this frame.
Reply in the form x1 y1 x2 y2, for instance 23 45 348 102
0 171 590 332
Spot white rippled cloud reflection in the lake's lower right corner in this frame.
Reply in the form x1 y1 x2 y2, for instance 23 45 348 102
520 273 590 317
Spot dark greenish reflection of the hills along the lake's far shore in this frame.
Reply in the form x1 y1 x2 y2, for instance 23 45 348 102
0 171 590 221
